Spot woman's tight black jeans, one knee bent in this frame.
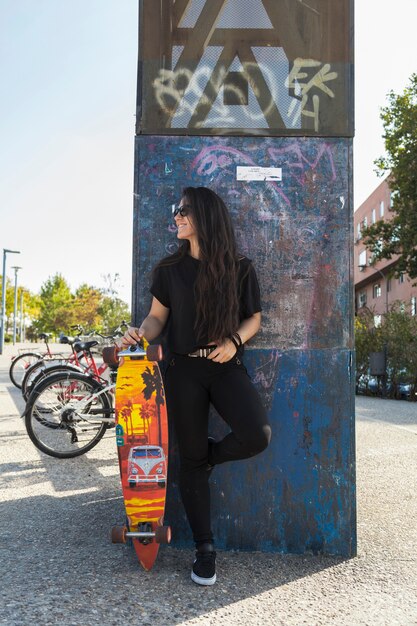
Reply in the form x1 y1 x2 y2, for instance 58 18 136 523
165 355 271 545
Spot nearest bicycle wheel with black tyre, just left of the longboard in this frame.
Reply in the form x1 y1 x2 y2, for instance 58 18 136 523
25 372 113 459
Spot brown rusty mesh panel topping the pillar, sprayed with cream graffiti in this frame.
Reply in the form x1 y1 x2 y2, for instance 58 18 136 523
137 0 353 137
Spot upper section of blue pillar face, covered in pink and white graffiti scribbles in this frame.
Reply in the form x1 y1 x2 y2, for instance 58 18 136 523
137 137 350 352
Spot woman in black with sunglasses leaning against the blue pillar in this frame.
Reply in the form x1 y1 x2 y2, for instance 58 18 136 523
122 187 271 585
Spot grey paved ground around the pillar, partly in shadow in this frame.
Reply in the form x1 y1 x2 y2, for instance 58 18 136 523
0 346 417 626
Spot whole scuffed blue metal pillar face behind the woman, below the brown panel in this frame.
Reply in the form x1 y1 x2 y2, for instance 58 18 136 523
133 135 356 556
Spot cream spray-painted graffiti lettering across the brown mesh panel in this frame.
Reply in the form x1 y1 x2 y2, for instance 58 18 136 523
153 56 338 133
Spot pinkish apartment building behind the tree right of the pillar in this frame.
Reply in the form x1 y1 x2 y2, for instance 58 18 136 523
354 177 417 323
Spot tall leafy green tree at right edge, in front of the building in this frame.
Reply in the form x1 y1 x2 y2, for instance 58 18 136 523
362 74 417 278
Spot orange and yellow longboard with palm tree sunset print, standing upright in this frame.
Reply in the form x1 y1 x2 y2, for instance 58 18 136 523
103 344 171 570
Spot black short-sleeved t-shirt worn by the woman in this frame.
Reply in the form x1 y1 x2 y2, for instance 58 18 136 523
150 255 261 354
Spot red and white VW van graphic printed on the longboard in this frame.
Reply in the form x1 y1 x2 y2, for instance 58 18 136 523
127 446 167 487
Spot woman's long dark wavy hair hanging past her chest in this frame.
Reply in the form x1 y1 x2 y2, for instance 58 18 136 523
158 187 239 341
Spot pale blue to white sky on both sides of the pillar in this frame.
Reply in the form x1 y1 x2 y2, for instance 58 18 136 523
0 0 417 304
